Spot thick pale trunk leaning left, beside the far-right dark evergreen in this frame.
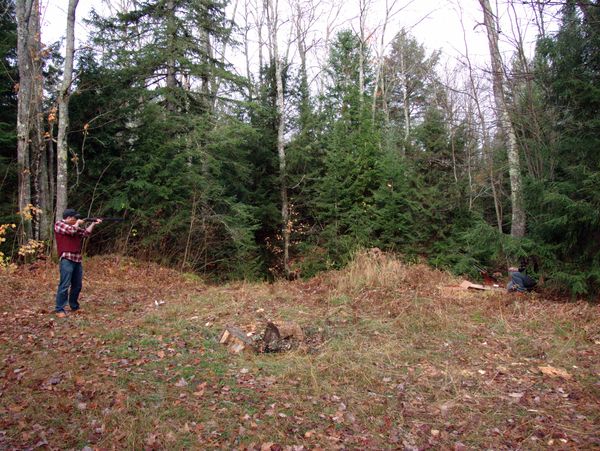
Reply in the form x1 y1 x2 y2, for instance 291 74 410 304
479 0 525 237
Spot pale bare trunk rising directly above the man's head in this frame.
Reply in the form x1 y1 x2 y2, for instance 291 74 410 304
56 0 79 221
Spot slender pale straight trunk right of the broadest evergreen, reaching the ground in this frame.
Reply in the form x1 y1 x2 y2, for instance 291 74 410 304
266 0 291 277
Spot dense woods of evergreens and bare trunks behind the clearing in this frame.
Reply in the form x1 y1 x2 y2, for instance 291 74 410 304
0 0 600 297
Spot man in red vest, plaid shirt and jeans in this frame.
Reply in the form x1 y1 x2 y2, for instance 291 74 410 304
54 208 102 318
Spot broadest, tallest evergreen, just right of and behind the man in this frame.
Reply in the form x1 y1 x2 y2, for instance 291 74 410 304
66 0 257 276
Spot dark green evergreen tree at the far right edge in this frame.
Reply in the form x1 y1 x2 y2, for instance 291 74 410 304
527 2 600 294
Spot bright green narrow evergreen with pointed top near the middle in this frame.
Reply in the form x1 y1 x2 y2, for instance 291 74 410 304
318 31 382 263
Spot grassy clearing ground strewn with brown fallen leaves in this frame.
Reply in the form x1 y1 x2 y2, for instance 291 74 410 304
0 254 600 450
